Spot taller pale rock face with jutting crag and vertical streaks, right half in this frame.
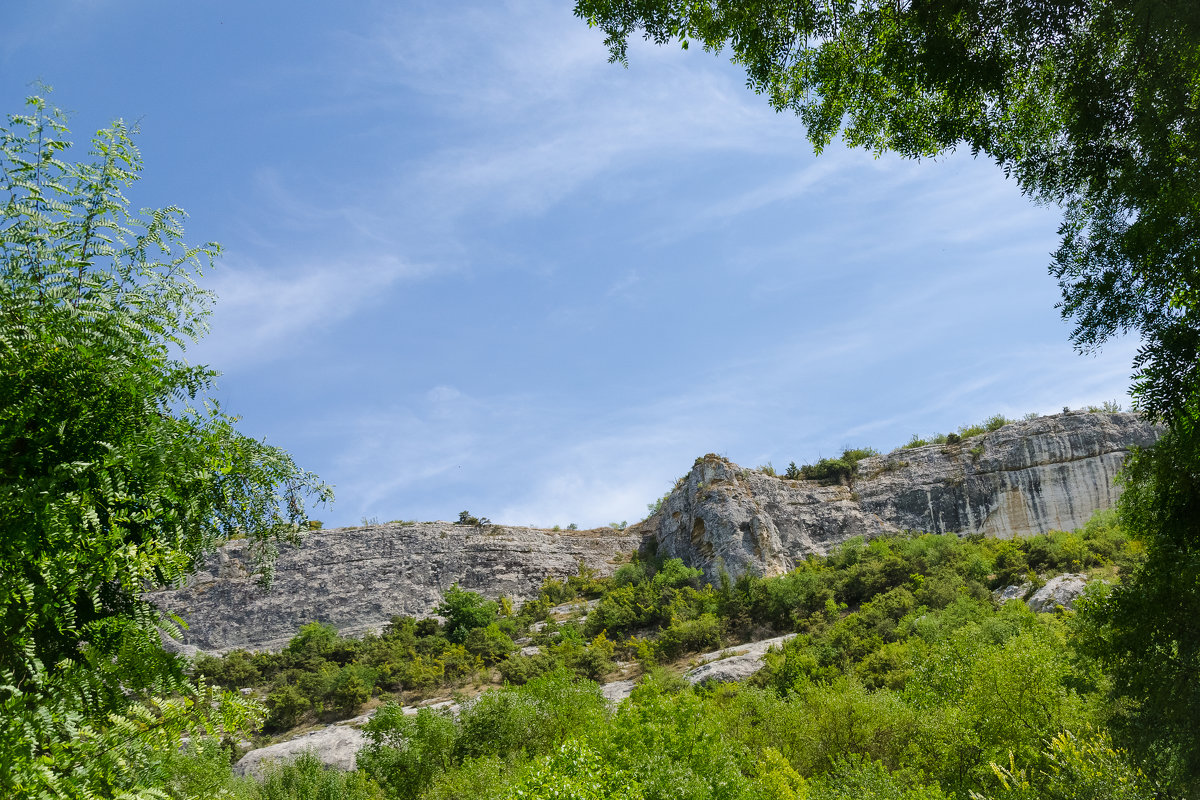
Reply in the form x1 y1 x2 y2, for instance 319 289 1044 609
644 413 1159 579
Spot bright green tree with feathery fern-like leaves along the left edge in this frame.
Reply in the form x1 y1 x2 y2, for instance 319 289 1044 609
0 97 331 796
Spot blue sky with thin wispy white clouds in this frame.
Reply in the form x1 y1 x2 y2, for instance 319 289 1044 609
0 0 1136 528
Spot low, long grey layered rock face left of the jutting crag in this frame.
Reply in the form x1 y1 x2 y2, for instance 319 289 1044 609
148 522 642 652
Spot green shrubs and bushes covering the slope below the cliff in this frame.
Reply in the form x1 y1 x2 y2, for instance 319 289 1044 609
174 512 1185 799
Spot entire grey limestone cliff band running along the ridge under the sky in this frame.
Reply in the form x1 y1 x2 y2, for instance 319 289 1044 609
150 413 1158 650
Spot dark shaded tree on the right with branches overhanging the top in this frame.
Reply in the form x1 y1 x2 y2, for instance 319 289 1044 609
575 0 1200 794
